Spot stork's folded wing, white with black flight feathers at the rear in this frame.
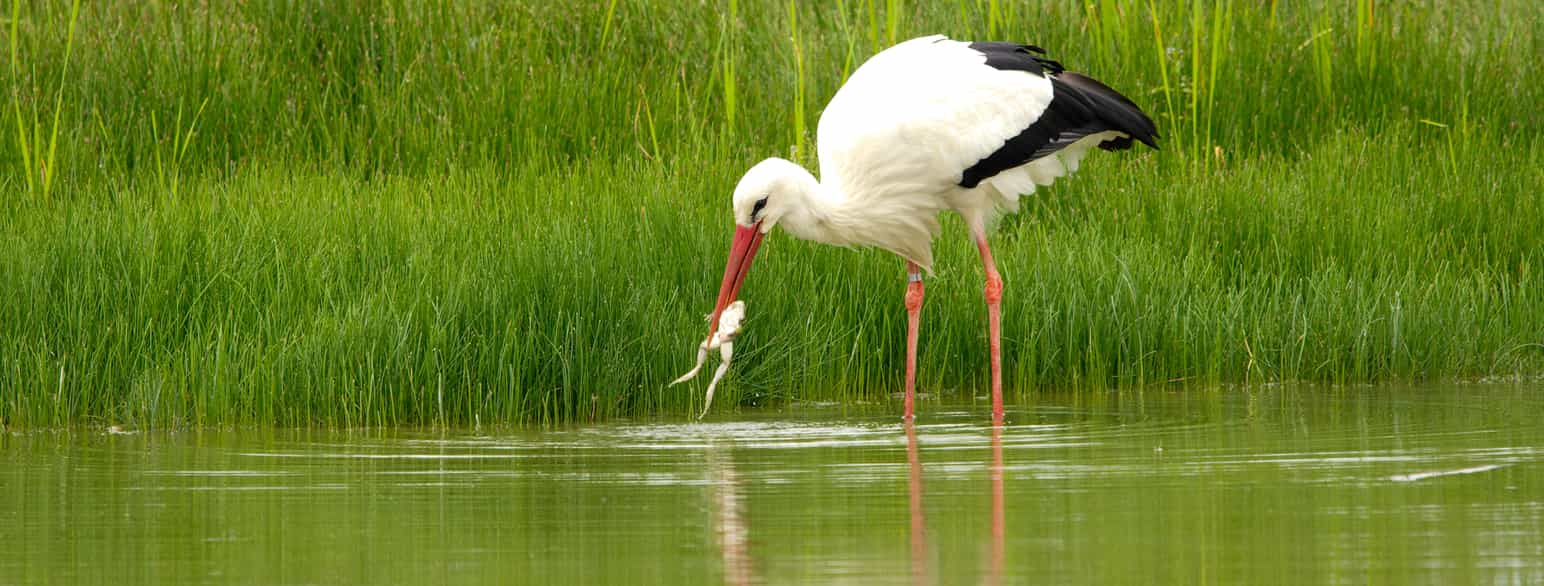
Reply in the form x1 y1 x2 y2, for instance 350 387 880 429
817 35 1156 197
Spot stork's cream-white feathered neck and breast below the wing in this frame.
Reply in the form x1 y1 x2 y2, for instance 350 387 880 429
778 165 939 267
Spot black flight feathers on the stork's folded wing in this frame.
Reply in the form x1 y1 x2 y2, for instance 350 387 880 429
959 42 1158 188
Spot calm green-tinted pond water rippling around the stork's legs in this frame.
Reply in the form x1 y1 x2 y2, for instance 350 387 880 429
0 386 1544 584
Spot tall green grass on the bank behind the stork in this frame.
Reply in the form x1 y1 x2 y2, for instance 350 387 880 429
0 0 1544 426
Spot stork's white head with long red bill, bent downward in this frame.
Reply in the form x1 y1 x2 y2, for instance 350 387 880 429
707 159 814 338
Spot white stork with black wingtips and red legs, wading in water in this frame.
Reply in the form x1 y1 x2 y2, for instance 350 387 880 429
709 35 1158 423
